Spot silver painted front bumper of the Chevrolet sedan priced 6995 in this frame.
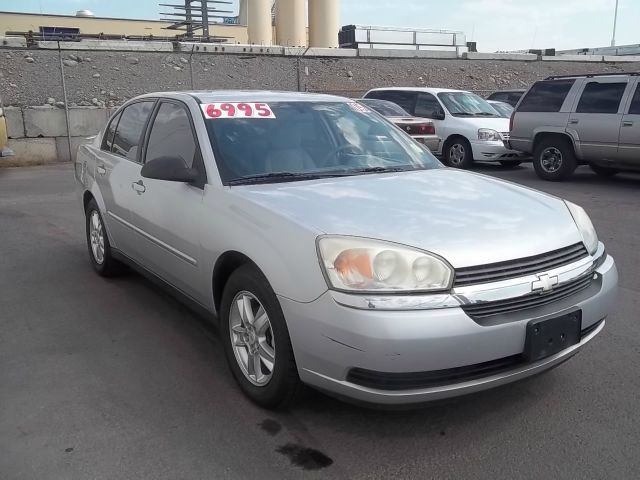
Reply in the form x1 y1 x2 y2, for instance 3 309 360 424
280 251 618 405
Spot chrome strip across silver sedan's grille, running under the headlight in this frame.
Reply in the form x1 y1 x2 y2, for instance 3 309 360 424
330 243 605 311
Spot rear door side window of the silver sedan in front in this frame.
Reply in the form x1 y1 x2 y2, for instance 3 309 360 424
111 101 155 162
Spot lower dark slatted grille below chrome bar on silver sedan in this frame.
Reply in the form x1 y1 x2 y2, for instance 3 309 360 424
462 274 593 320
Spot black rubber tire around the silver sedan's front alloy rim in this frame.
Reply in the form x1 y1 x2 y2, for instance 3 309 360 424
220 265 302 409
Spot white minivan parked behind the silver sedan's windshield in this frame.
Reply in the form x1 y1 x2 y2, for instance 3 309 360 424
365 87 527 168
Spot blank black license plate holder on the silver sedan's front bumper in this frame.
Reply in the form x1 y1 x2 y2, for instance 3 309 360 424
524 310 582 362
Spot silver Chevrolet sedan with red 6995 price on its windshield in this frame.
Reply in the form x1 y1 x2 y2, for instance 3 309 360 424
75 91 617 408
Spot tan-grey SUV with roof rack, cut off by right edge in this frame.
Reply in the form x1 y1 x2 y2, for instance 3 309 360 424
510 73 640 181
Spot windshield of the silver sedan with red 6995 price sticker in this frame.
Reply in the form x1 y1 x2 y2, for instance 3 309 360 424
203 101 442 185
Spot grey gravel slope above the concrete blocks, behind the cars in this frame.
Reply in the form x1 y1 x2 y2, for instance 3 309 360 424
0 48 640 106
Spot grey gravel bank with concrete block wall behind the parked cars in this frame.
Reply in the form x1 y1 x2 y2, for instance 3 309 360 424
0 38 640 164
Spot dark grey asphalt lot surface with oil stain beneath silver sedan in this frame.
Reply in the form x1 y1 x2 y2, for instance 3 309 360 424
0 165 640 480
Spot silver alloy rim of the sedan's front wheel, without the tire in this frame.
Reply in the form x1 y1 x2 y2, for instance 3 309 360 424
229 291 276 386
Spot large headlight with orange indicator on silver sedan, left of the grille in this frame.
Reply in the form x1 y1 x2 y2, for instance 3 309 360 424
318 236 453 293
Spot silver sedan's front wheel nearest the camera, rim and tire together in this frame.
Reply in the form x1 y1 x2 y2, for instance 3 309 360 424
220 265 302 408
